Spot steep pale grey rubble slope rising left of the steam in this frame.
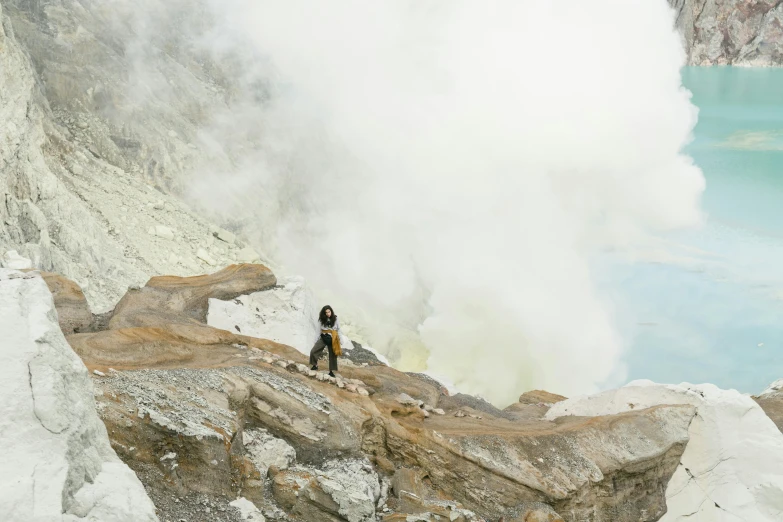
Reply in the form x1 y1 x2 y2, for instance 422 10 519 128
0 1 266 310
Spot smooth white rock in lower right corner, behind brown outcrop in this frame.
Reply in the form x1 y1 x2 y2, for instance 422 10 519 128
546 381 783 522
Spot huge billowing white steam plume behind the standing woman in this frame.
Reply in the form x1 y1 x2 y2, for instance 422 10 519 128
188 0 704 405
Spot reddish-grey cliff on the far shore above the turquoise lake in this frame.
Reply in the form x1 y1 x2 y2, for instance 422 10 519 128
669 0 783 66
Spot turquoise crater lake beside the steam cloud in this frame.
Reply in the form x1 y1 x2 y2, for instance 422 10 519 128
616 67 783 393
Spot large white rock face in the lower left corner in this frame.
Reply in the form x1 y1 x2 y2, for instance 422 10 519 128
0 270 158 522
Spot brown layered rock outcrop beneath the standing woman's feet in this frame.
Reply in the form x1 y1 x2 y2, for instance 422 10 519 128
59 267 694 522
